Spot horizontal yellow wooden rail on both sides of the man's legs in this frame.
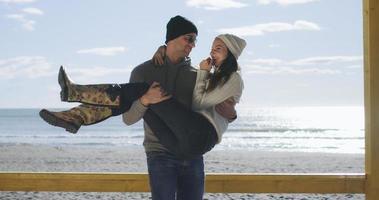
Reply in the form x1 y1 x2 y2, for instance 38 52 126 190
0 172 365 193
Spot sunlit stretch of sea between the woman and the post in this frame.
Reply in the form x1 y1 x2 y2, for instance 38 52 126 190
217 106 364 153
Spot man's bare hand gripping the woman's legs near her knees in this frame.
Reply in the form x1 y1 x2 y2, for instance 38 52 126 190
140 82 171 106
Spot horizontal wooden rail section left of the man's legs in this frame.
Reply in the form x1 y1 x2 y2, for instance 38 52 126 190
0 173 150 192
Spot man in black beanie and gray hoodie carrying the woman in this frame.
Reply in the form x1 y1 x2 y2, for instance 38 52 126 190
123 16 235 200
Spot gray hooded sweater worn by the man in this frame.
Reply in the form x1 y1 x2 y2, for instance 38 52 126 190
122 59 196 152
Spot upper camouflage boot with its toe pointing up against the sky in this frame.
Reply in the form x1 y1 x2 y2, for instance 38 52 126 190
58 66 120 107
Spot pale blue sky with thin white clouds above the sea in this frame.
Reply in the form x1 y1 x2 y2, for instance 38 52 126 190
0 0 363 108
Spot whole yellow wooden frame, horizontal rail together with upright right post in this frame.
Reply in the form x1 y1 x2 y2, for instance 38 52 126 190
0 0 379 200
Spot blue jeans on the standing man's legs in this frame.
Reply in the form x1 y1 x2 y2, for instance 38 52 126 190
147 152 204 200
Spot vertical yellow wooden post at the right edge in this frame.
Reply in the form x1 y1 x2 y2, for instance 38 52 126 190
363 0 379 200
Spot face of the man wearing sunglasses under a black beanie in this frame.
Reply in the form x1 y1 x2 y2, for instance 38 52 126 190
170 33 197 58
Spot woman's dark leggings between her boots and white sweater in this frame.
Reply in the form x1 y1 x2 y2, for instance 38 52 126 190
112 83 218 158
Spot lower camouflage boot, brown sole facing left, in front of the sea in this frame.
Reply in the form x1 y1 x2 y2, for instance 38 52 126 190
39 104 112 133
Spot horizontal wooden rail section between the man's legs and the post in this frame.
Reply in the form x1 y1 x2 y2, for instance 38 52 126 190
206 174 365 193
